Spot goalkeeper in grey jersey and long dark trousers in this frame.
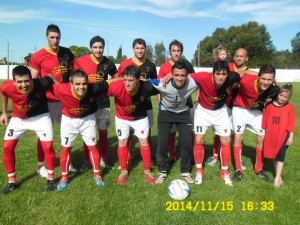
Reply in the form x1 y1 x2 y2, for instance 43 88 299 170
150 61 199 183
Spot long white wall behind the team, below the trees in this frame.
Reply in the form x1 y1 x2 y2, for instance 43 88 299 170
0 65 300 82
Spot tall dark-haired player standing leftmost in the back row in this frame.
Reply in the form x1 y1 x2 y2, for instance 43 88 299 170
30 24 75 176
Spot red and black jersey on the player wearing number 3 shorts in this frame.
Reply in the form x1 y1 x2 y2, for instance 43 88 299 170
1 76 53 119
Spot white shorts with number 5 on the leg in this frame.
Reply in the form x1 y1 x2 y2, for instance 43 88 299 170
115 117 149 140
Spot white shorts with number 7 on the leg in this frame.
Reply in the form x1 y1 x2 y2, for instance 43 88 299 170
60 114 97 147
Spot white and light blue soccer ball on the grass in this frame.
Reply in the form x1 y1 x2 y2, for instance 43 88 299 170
168 179 190 200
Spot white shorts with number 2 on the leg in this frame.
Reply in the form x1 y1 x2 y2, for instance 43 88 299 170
232 106 265 135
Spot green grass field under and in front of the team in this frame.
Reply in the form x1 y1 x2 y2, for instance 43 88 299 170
0 83 300 225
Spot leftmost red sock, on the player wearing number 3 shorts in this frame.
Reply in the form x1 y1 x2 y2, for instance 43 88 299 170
2 139 19 177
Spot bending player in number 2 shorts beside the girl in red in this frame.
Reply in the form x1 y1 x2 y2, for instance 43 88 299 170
232 64 279 182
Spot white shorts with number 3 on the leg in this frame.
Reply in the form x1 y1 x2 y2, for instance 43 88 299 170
4 113 53 141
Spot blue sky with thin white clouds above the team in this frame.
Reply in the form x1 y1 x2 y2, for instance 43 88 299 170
0 0 300 62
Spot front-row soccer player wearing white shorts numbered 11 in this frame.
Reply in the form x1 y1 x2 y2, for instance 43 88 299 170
191 60 250 186
